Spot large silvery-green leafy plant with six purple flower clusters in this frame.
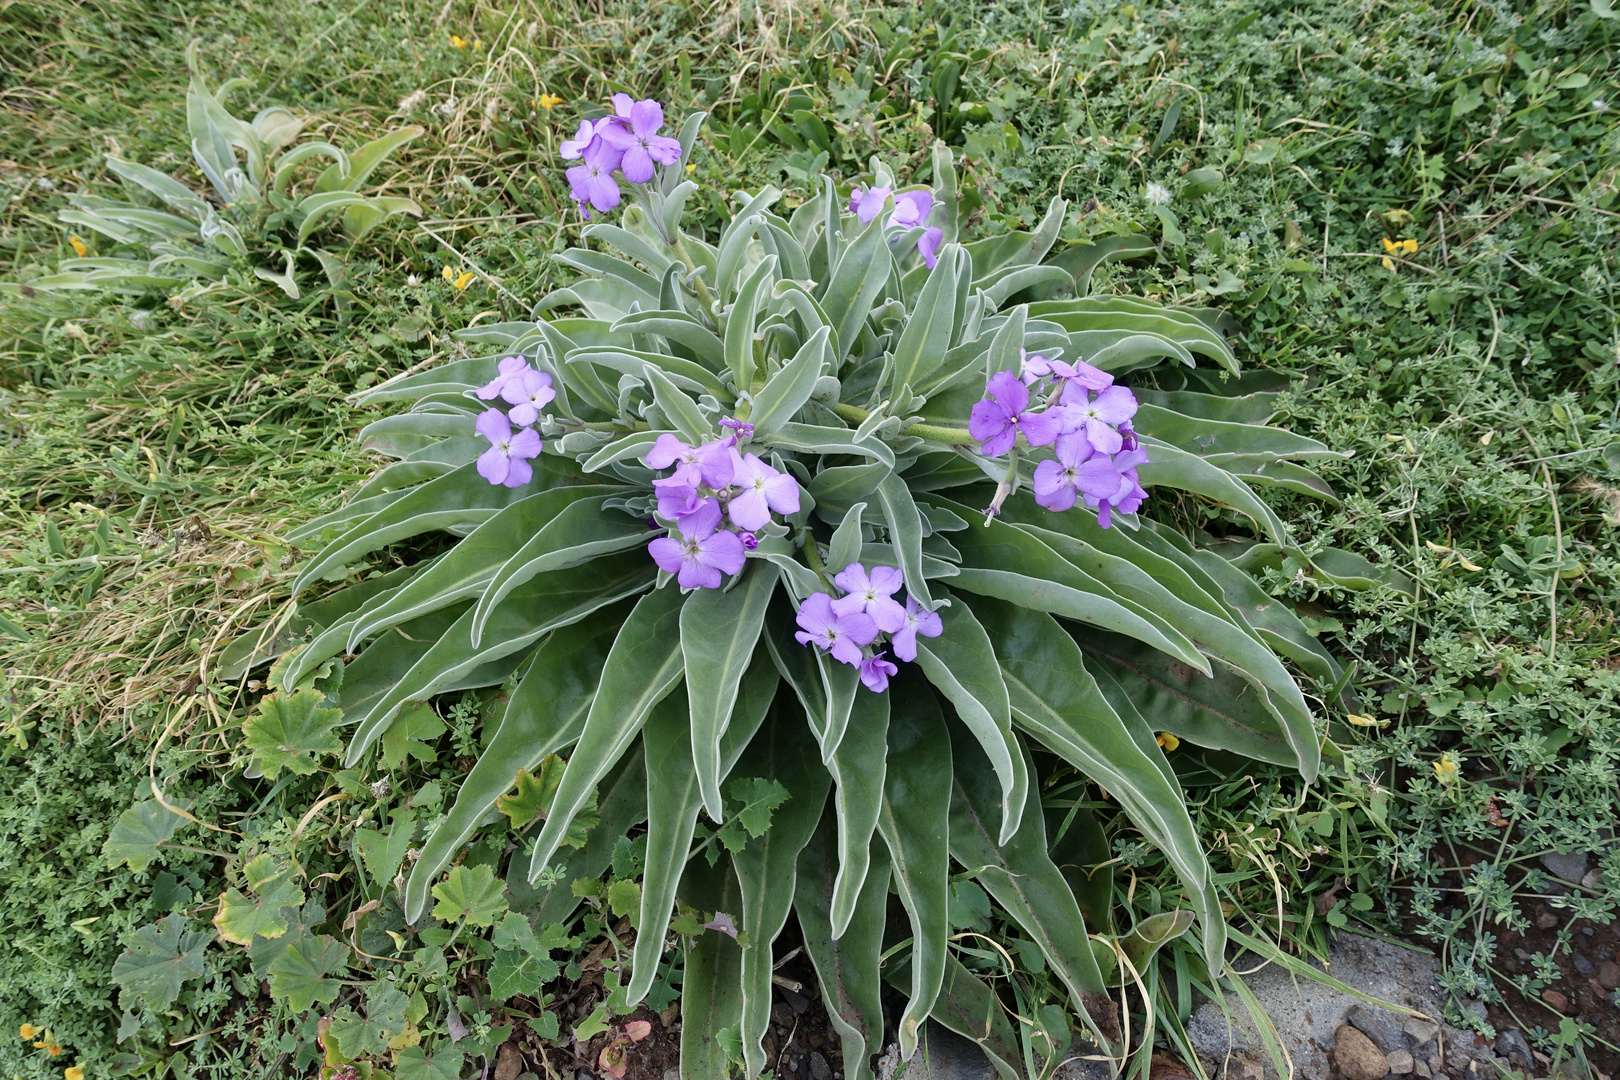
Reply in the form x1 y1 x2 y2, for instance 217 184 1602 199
246 99 1356 1080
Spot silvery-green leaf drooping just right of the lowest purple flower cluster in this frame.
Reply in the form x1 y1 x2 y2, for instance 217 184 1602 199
917 593 1029 844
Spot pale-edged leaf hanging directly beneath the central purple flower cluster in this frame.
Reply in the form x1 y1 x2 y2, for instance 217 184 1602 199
680 560 778 823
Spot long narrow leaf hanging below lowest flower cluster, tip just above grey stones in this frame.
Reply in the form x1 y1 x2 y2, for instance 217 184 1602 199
878 680 951 1061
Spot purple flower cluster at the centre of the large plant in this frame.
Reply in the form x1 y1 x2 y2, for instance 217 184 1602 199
642 433 799 589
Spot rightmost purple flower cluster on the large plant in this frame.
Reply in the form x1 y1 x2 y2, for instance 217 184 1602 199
967 353 1147 528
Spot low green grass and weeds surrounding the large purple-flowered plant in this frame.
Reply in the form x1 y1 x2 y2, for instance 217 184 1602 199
0 3 1620 1075
